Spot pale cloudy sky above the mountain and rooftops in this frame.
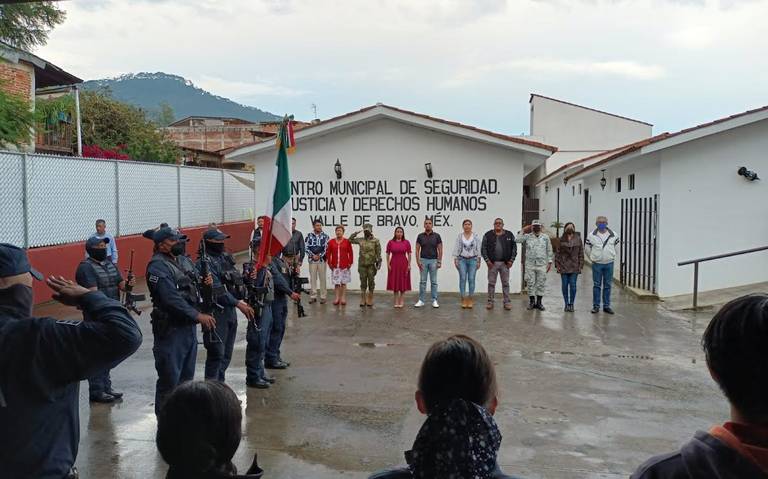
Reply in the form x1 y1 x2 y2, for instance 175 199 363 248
37 0 768 134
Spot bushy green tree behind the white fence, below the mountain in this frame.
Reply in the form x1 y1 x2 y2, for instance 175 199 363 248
80 91 179 163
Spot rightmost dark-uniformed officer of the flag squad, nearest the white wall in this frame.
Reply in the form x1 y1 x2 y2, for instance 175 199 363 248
264 256 299 369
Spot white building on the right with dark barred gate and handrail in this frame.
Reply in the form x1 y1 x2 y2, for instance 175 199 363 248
535 107 768 297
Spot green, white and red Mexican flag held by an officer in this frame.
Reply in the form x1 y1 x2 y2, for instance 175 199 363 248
258 117 296 265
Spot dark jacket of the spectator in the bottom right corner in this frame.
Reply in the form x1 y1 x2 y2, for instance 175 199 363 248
631 431 768 479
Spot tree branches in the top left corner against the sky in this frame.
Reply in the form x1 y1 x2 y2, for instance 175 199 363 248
0 2 66 50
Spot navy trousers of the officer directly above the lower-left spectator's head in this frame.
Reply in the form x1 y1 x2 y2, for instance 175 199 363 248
152 325 197 414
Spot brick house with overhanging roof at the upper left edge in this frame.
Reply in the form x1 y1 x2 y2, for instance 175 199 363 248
0 42 83 155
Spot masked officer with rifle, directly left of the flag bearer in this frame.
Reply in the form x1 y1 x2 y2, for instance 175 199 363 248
195 228 253 382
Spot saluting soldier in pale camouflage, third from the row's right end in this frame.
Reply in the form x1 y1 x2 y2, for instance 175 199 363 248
515 220 554 311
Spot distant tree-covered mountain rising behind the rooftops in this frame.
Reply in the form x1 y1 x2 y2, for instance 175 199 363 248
82 72 280 122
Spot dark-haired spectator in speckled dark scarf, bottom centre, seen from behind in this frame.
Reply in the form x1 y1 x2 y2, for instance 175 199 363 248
369 335 511 479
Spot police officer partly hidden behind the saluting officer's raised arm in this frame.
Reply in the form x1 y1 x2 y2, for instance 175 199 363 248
75 236 133 403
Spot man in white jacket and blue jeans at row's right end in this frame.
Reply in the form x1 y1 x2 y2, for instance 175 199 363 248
585 216 619 314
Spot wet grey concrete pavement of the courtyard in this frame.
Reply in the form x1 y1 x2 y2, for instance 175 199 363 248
37 270 728 479
